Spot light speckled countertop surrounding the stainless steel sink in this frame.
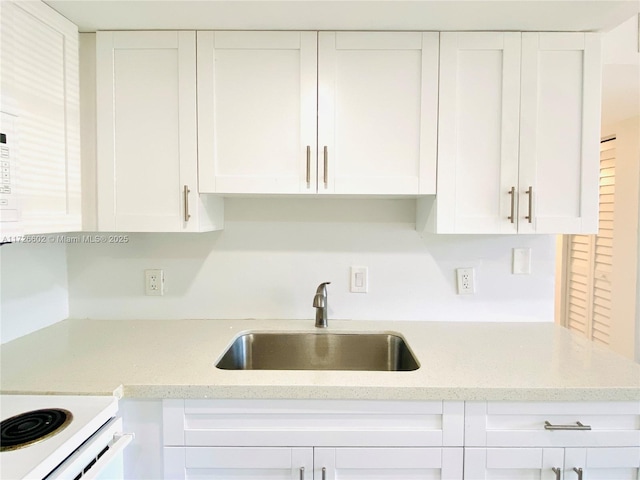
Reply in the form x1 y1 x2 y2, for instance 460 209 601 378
0 320 640 401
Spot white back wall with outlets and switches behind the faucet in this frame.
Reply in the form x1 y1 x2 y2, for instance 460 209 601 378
67 198 555 321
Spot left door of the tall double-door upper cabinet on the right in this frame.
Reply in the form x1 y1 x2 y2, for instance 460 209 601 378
436 33 520 233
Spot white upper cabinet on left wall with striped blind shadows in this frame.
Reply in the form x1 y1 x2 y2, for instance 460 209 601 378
0 1 82 236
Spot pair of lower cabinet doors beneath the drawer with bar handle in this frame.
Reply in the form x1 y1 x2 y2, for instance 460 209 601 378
464 447 640 480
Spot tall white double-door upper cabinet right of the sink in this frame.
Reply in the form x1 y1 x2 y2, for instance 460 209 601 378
420 32 600 233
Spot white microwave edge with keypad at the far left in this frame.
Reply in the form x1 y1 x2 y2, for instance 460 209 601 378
0 112 21 242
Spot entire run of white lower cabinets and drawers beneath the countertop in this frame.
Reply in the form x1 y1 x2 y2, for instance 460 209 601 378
163 400 640 480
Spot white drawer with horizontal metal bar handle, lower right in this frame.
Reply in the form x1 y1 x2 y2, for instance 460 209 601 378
465 402 640 447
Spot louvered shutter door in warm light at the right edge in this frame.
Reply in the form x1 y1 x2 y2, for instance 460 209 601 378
563 139 616 345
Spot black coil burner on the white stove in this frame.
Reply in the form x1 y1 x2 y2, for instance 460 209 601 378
0 408 73 452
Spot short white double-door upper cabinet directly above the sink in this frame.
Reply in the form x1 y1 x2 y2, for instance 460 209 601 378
198 32 438 195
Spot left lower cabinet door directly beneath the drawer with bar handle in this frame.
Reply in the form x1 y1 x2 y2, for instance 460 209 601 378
464 448 564 480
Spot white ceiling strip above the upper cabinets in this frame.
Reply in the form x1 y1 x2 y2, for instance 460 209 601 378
45 0 640 32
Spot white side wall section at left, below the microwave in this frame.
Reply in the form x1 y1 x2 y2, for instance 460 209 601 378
0 243 69 343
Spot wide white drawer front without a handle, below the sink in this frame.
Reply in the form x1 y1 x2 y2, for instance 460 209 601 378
163 400 464 447
